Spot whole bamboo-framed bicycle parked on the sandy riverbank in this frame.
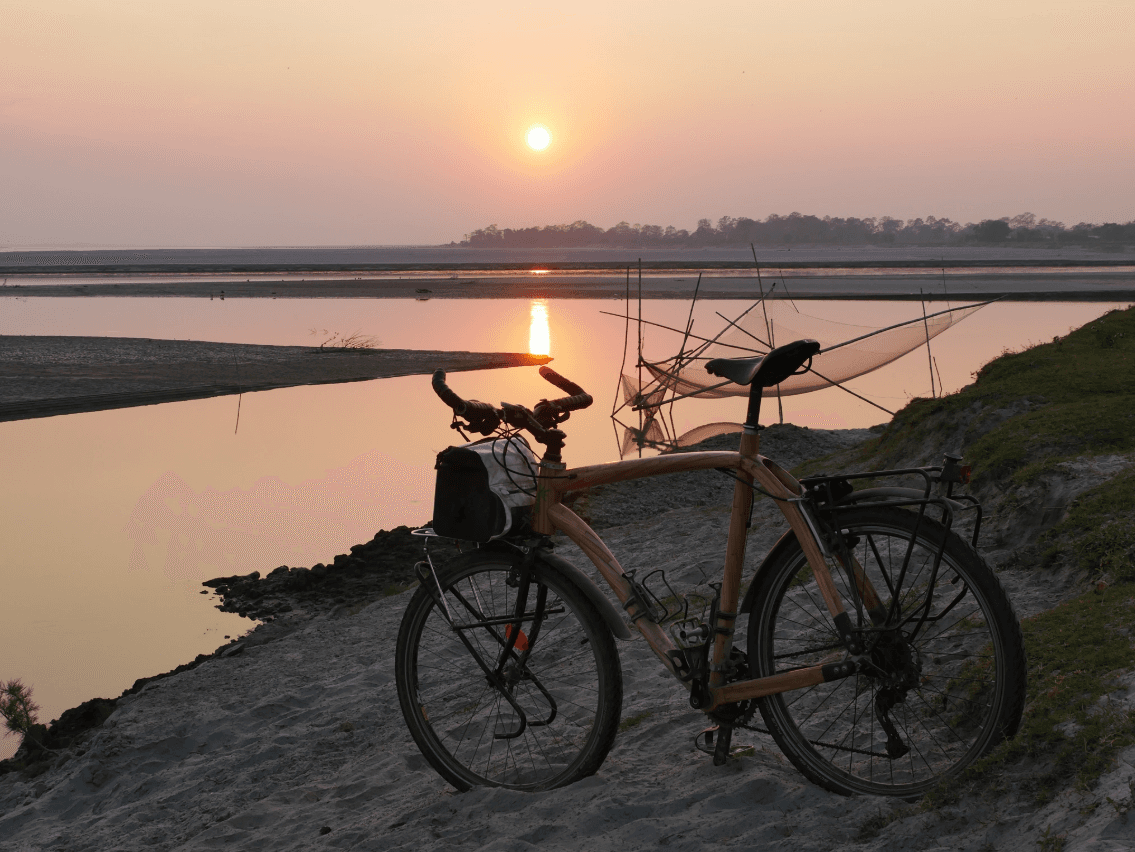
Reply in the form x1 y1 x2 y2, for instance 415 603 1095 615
395 340 1025 799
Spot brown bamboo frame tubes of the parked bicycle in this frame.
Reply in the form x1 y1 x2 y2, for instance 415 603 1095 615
532 432 858 711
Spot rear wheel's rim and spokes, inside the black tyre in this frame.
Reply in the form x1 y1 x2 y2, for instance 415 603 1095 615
756 512 1003 795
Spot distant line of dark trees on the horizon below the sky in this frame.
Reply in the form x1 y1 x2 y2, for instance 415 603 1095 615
461 213 1135 248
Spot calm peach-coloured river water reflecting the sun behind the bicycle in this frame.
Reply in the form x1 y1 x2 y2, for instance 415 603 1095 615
0 297 1119 757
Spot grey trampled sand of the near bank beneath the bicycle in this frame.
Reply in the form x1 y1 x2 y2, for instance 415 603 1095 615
0 428 1135 852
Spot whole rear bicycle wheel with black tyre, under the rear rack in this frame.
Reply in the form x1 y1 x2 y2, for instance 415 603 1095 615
748 506 1026 799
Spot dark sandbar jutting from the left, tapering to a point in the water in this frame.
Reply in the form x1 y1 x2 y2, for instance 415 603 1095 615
0 336 550 421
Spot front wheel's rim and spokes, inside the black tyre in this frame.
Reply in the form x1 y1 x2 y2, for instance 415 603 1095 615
412 563 600 790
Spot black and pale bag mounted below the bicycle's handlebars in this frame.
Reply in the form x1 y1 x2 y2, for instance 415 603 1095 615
434 436 538 543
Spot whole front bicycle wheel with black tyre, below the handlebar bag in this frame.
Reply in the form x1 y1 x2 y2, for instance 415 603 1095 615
395 551 623 791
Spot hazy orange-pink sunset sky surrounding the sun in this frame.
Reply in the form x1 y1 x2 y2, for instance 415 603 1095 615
0 0 1135 247
